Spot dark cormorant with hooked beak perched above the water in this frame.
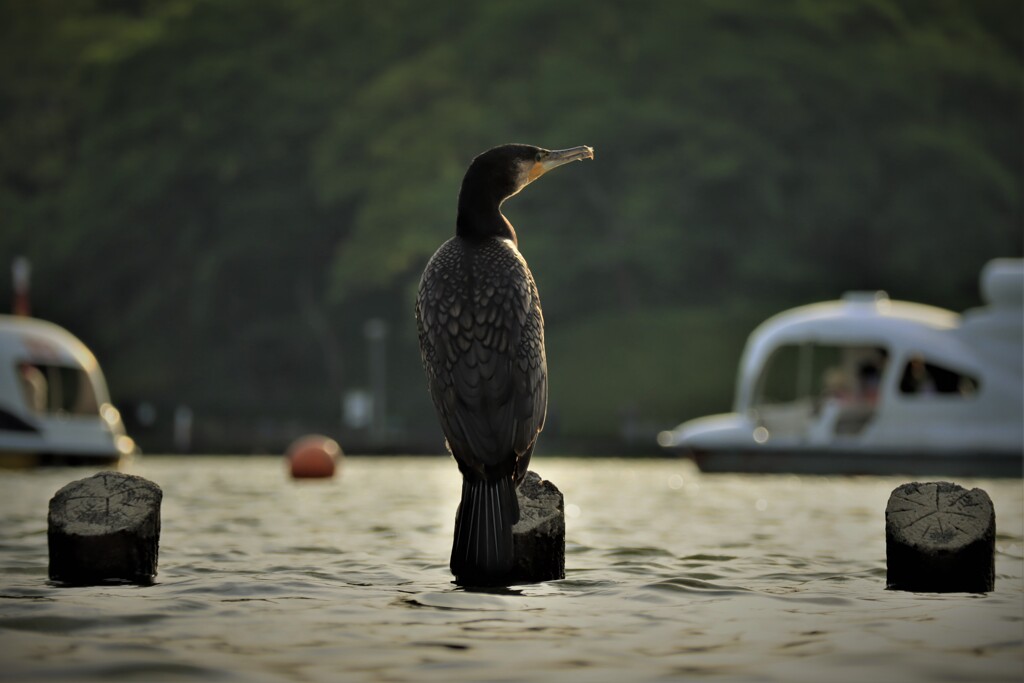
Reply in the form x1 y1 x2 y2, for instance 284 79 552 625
416 144 594 586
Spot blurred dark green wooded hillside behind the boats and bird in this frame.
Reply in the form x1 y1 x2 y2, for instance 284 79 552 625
0 0 1024 450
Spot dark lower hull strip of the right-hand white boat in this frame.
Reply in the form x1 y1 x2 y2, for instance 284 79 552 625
686 447 1024 478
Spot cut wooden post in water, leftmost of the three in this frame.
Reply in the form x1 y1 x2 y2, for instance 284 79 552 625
47 472 163 586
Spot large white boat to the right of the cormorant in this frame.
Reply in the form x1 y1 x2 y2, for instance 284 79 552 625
658 259 1024 477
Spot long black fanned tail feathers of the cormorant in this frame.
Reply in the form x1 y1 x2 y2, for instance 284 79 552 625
451 476 519 586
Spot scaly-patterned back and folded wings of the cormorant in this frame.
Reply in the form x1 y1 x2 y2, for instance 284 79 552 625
417 241 547 478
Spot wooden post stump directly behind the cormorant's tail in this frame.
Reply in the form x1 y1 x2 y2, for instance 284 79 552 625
512 472 565 583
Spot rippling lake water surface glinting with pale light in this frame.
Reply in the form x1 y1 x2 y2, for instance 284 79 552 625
0 457 1024 681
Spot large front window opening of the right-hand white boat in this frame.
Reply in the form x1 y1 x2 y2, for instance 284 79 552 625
753 342 889 438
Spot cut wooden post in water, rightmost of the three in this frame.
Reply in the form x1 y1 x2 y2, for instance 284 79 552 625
886 481 995 593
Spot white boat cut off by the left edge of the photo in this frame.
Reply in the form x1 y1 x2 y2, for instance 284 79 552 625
0 315 136 467
